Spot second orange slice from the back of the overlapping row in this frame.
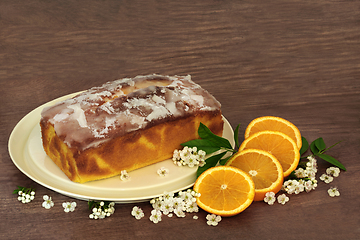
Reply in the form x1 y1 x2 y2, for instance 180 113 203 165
239 131 300 177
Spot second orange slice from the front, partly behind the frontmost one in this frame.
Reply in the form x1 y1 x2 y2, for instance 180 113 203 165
226 149 284 201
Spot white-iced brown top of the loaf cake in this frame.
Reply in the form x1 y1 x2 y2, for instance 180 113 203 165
41 74 220 150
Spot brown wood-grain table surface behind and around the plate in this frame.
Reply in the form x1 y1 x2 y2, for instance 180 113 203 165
0 0 360 239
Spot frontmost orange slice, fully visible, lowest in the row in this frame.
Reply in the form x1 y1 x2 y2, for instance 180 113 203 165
193 166 255 217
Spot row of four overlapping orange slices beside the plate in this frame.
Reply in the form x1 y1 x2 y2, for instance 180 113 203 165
194 116 302 216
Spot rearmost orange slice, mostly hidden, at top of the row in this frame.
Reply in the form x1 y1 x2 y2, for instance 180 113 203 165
245 116 302 149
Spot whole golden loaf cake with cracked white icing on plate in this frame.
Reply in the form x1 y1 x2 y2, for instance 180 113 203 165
40 75 223 183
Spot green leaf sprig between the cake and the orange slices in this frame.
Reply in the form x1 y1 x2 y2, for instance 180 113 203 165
181 123 240 177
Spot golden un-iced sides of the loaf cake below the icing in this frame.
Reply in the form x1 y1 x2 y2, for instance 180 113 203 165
40 109 223 183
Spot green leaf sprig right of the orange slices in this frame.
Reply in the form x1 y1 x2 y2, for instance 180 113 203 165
300 137 346 171
